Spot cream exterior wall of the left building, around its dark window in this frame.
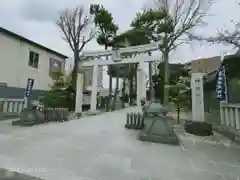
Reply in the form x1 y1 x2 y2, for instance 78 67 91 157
0 33 65 90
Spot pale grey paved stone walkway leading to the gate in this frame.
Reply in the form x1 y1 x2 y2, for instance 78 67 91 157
0 107 240 180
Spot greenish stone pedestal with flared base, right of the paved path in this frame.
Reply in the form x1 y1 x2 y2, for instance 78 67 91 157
139 101 179 145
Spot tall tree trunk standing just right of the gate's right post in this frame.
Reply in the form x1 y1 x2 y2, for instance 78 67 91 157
163 50 169 106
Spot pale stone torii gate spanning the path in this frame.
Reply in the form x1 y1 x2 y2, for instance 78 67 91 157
75 42 161 115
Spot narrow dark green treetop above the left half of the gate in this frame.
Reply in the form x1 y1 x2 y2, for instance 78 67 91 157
90 4 118 49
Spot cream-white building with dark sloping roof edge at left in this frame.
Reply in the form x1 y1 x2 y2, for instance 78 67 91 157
0 27 67 98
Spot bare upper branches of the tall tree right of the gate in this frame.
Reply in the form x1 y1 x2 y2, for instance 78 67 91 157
156 0 212 50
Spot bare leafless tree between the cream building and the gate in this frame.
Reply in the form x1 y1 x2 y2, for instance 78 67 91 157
56 6 95 89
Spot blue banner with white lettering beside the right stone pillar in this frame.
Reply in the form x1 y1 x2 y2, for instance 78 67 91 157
216 67 227 101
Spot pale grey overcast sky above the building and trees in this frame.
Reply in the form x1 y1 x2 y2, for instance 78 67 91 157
0 0 240 87
